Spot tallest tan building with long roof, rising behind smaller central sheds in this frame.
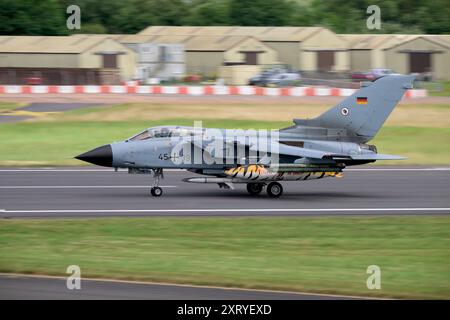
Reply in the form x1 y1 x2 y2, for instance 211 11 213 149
138 26 350 73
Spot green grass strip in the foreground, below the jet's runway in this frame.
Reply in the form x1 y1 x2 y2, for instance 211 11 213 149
0 216 450 299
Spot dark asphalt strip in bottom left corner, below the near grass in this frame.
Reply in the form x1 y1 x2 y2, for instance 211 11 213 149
0 275 352 300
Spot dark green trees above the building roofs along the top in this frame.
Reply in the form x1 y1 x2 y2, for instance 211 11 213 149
0 0 450 35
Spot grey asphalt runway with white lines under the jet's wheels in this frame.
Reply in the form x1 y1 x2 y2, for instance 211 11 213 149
0 167 450 218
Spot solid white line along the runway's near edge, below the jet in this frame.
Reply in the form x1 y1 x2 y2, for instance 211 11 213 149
0 208 450 213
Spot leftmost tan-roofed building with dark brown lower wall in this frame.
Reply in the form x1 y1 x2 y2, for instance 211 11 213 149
0 35 136 85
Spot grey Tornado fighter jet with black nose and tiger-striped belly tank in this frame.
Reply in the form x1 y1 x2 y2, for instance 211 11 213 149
76 75 414 198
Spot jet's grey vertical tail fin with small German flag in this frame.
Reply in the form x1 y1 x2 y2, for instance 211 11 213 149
313 75 414 142
